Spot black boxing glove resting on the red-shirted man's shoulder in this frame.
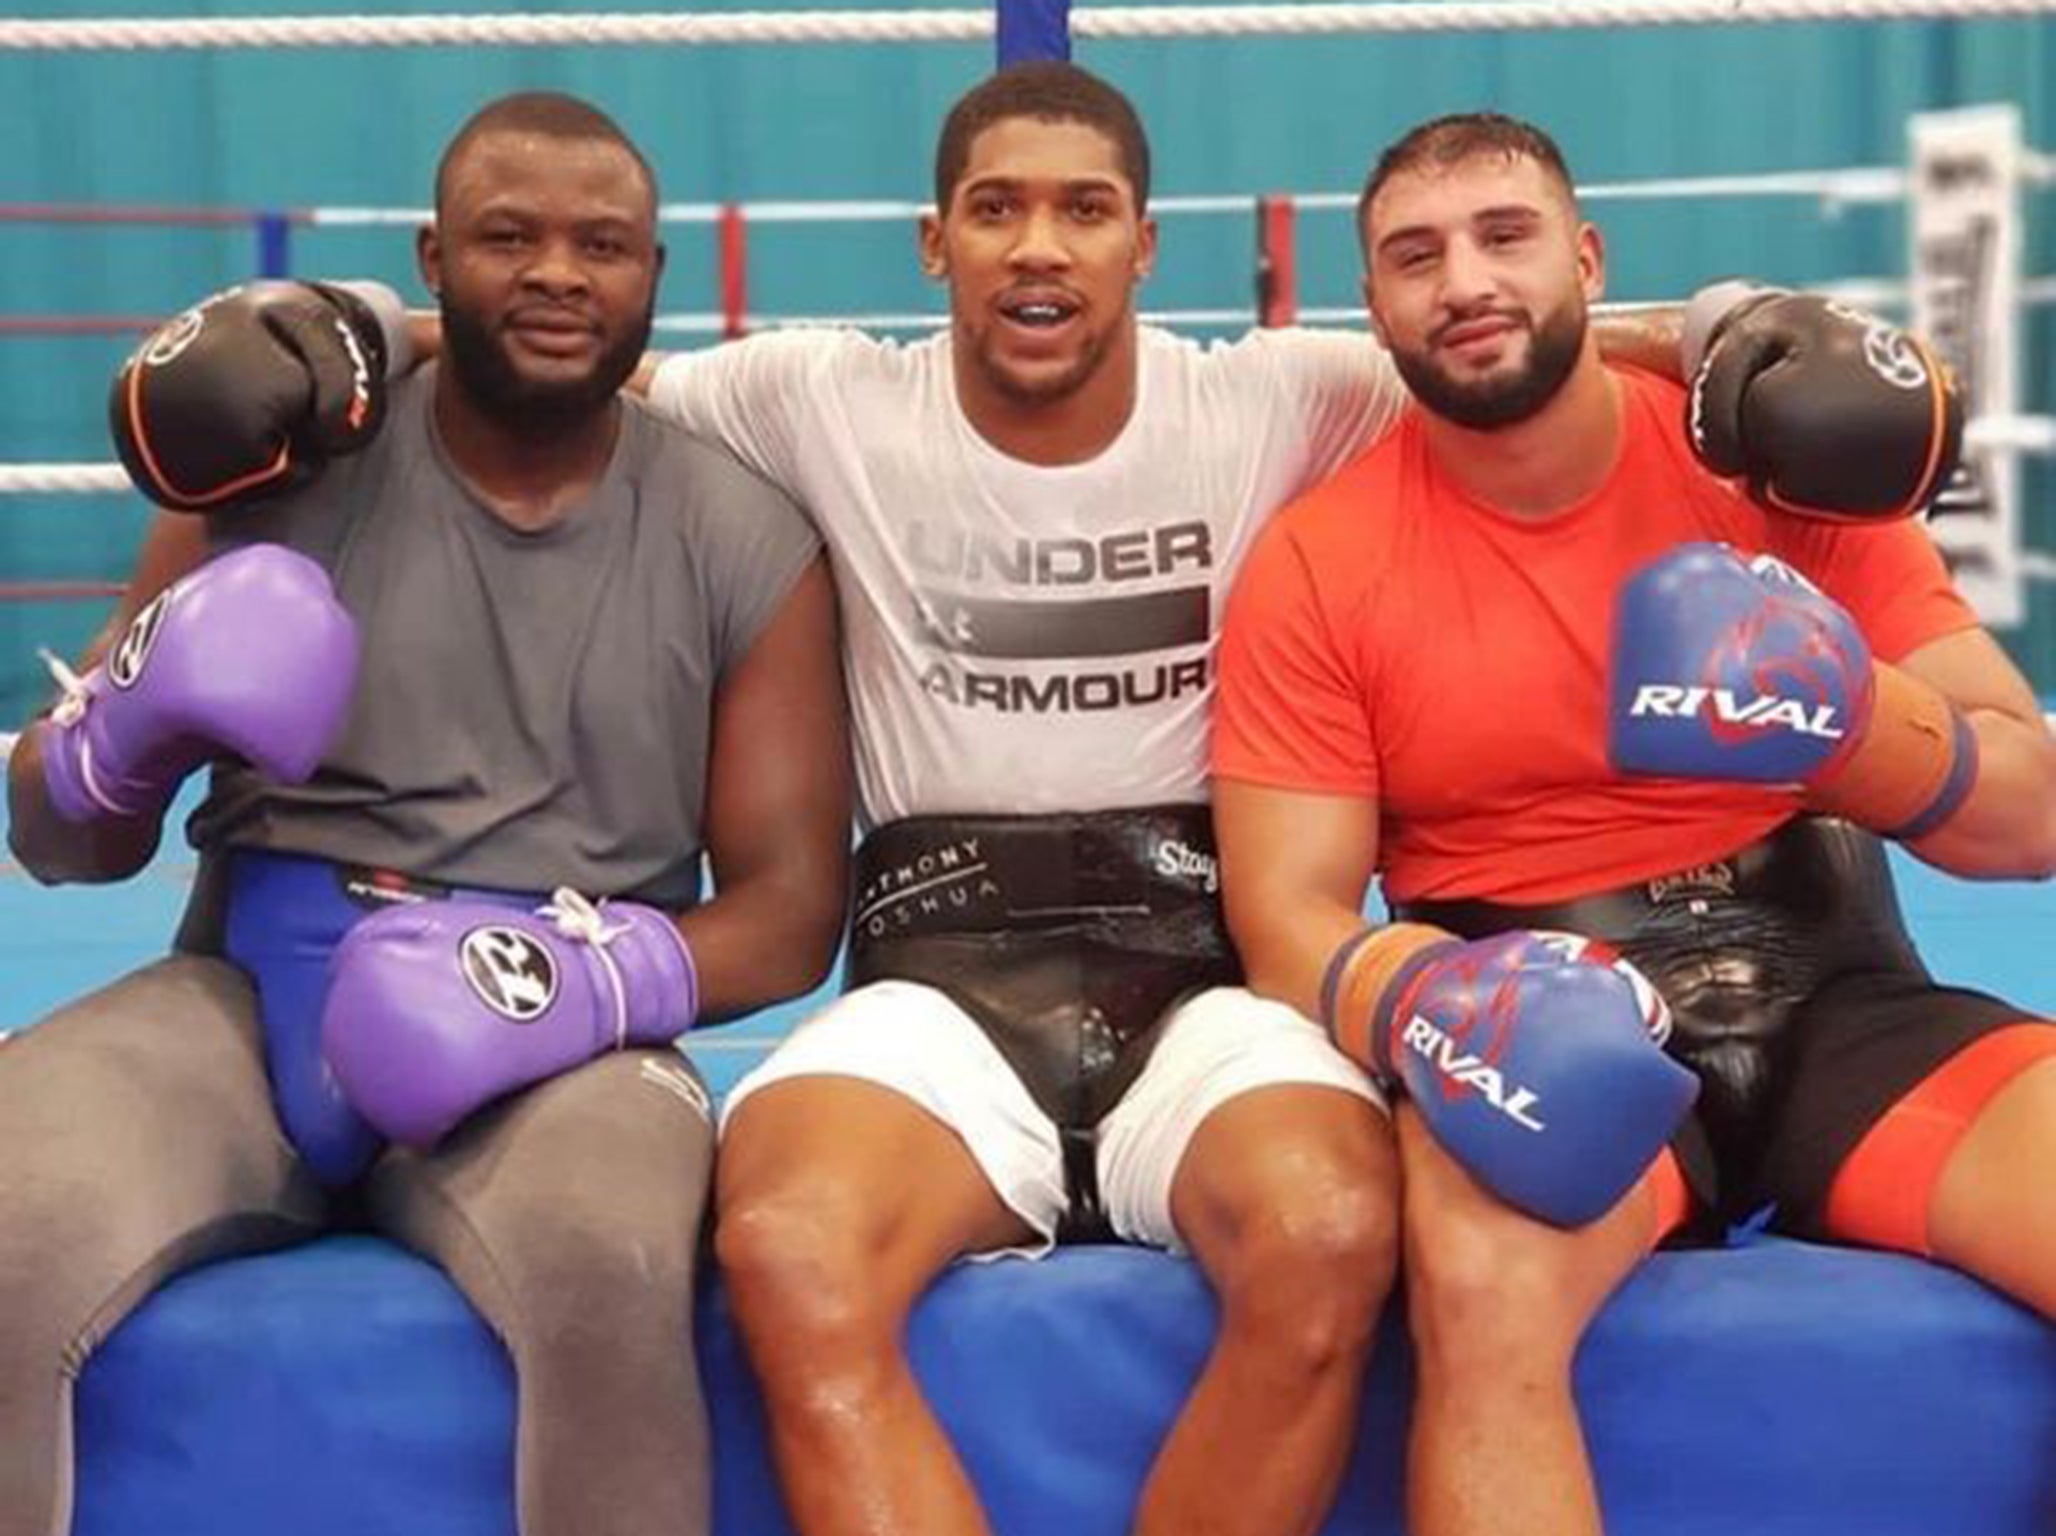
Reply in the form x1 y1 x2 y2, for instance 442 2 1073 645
1684 282 1963 520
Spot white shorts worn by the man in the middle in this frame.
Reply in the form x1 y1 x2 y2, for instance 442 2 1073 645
722 981 1384 1256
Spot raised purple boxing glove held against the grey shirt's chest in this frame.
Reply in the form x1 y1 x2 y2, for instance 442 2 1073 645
41 545 358 822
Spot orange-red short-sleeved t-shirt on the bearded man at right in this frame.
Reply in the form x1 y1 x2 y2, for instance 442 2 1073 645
1213 370 1978 903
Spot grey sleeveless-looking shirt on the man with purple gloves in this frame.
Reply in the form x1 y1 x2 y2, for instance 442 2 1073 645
189 368 818 907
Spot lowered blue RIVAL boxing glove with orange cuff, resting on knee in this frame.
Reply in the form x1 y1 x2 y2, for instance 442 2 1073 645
1322 923 1698 1228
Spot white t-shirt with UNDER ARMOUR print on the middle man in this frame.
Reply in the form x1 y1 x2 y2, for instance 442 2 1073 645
650 327 1406 825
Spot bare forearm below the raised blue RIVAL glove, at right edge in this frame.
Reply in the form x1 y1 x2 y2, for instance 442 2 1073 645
1908 709 2056 880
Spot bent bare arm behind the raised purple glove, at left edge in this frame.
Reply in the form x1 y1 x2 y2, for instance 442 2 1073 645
6 512 208 884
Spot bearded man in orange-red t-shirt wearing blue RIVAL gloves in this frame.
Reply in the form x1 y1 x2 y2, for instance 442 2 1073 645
1213 115 2056 1536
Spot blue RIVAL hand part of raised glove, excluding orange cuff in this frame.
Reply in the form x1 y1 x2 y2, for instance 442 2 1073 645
1606 543 1877 783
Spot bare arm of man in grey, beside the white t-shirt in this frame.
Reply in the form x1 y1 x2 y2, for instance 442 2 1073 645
678 559 851 1020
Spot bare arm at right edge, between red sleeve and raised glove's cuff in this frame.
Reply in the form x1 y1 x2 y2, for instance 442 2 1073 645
1900 629 2056 880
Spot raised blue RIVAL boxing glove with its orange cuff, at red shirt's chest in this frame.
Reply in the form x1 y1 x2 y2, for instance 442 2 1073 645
1608 543 1978 841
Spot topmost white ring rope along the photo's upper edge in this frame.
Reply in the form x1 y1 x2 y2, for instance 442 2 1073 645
12 0 2056 51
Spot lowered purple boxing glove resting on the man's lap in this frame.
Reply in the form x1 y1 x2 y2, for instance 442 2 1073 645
321 890 699 1147
